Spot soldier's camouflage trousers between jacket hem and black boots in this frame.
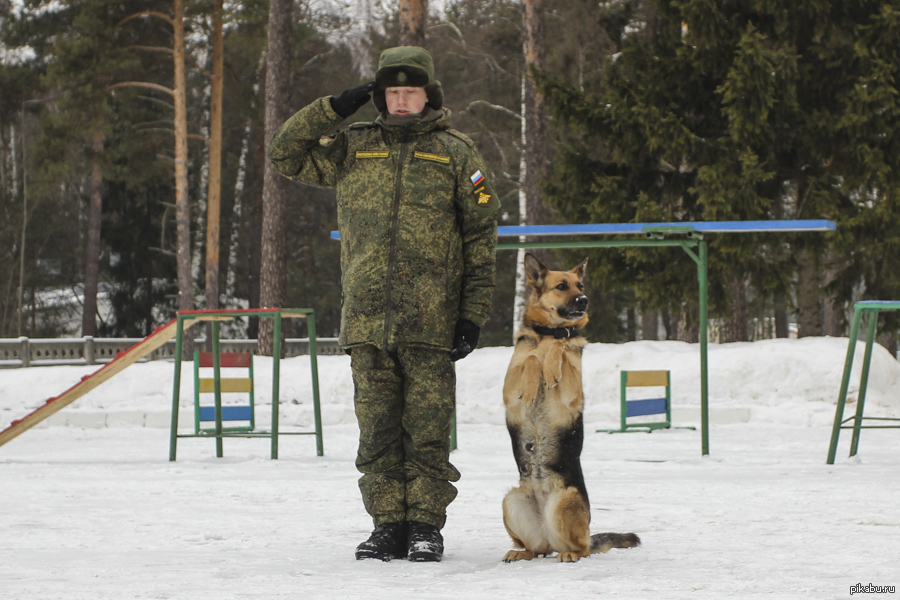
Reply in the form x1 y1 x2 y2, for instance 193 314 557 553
351 345 460 528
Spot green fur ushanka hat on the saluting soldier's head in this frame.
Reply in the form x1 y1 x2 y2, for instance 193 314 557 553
372 46 444 112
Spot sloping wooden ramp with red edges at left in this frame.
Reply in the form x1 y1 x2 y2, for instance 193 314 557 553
0 319 183 446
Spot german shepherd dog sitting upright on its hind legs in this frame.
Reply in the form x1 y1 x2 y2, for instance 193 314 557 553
503 253 641 562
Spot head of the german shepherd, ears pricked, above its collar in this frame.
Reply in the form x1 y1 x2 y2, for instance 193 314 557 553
525 253 588 327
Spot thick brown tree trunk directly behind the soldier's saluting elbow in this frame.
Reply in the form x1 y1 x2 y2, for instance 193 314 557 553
258 0 292 356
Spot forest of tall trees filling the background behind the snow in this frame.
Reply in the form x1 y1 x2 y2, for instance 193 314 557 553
0 0 900 352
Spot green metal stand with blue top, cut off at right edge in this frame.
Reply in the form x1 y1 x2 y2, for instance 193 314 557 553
827 300 900 465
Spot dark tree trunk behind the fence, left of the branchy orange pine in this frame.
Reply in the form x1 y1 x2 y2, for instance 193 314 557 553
81 130 103 336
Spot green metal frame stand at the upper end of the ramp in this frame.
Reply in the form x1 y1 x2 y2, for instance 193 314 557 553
169 308 324 461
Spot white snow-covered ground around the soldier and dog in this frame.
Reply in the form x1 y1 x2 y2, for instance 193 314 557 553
0 338 900 600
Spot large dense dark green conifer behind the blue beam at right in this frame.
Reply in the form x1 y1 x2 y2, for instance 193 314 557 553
544 0 897 342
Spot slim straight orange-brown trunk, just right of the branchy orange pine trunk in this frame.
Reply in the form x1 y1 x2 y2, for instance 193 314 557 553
206 0 224 309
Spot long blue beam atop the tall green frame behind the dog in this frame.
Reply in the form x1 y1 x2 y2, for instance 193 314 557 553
331 219 836 240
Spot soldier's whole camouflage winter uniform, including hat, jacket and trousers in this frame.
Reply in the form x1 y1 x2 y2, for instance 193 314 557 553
268 48 499 527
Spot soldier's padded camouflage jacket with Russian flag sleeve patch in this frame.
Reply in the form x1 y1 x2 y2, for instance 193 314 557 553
268 97 499 349
